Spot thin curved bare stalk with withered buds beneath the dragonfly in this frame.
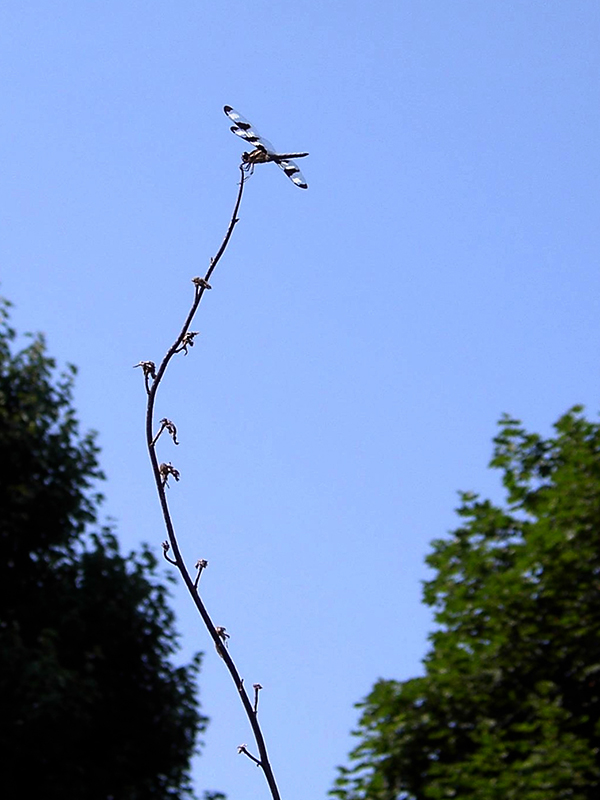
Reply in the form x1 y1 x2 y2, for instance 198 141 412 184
136 165 281 800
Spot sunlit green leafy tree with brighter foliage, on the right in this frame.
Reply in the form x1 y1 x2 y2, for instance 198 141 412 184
331 407 600 800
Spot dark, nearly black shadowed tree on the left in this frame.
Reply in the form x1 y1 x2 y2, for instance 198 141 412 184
0 302 206 800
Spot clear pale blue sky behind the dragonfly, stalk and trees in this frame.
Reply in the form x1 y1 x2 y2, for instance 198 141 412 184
0 0 600 800
